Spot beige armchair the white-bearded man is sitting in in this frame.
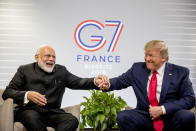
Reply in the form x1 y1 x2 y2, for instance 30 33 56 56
0 89 80 131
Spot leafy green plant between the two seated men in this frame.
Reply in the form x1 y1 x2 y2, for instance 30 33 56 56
80 90 126 131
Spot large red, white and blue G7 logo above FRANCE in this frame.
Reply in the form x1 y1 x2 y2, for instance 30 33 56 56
74 20 124 52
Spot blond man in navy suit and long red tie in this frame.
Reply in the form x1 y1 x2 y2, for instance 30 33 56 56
99 40 195 131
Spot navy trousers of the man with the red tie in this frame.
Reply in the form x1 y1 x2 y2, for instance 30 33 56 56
117 109 195 131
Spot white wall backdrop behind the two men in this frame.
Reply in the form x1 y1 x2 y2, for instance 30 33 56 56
0 0 196 107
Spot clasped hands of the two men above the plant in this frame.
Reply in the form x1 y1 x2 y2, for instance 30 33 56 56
94 75 110 90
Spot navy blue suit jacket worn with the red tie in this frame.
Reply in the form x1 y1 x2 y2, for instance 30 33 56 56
110 62 195 114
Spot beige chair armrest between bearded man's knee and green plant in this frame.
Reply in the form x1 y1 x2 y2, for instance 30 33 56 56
62 104 80 131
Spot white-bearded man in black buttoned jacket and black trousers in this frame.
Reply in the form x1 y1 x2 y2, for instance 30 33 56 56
3 46 99 131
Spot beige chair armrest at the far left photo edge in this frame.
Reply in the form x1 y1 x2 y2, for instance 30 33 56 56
0 98 14 131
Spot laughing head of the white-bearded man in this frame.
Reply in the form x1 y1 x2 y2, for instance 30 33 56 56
35 46 56 73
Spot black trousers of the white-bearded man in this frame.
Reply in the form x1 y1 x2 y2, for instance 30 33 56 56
16 110 79 131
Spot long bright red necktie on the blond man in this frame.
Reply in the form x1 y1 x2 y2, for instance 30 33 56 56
148 71 163 131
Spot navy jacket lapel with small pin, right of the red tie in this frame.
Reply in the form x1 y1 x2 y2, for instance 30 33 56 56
159 63 174 103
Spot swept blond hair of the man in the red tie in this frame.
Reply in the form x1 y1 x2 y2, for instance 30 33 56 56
144 40 169 61
